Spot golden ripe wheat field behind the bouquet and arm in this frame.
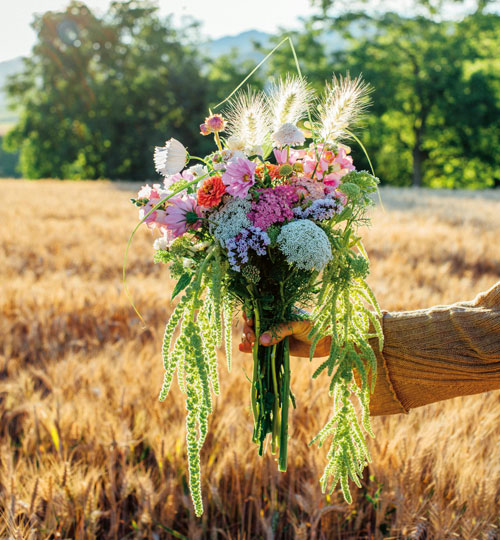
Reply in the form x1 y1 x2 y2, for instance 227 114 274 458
0 180 500 540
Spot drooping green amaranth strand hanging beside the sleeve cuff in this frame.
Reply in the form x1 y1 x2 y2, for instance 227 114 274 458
309 172 383 502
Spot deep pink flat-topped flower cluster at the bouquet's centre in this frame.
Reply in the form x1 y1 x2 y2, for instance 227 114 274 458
247 186 297 230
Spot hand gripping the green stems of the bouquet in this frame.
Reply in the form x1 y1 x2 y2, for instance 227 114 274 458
239 314 331 358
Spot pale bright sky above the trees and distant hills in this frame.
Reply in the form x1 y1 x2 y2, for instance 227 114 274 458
0 0 316 62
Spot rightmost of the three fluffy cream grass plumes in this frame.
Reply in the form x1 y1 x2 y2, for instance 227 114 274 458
318 74 371 141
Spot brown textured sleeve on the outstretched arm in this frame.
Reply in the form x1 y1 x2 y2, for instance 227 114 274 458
370 282 500 416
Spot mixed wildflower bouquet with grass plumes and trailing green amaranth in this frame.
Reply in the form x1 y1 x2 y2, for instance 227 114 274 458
127 71 382 515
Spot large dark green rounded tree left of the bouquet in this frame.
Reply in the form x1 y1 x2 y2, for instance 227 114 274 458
5 0 207 179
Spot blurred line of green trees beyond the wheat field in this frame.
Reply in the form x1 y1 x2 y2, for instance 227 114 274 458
3 0 500 188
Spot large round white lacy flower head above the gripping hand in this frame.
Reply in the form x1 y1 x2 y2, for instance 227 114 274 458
277 219 332 271
